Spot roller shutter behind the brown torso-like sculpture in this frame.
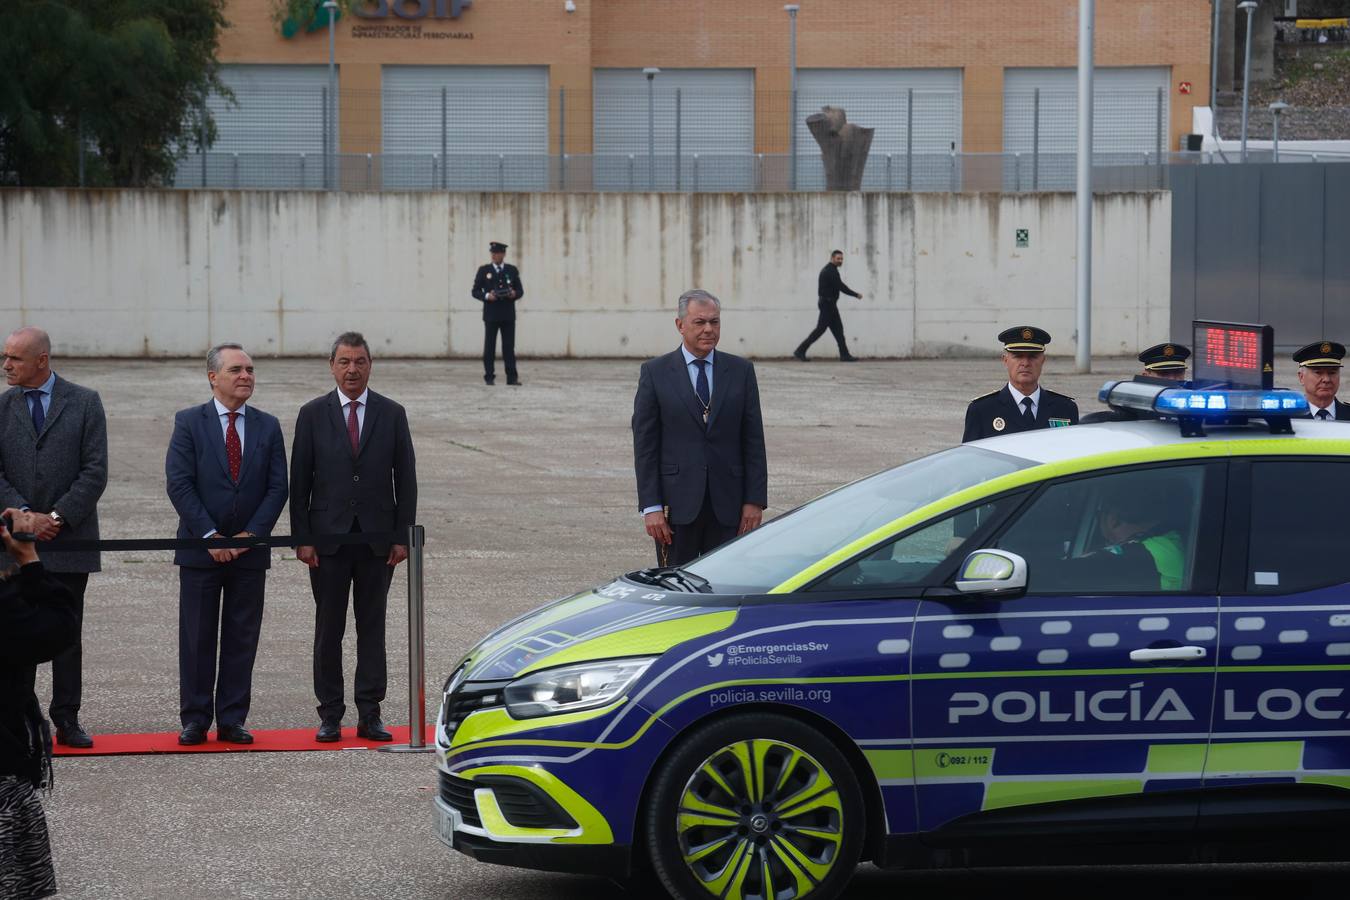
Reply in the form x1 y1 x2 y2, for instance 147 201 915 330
795 69 961 190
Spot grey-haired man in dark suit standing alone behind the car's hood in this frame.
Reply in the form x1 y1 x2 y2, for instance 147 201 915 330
633 290 768 565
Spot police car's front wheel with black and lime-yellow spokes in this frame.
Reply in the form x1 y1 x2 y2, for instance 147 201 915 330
644 714 865 900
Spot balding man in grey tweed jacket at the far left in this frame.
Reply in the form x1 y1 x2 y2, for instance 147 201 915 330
0 328 108 748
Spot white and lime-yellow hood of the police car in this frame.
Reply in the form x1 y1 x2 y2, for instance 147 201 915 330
456 580 737 681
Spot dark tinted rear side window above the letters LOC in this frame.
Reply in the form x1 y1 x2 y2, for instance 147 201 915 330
1246 459 1350 594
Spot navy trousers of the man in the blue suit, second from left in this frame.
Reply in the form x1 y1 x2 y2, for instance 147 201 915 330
178 566 267 729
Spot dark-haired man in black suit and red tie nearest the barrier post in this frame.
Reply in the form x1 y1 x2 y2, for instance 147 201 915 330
290 332 417 743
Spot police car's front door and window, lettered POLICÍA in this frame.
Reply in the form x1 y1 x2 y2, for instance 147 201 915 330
911 463 1224 845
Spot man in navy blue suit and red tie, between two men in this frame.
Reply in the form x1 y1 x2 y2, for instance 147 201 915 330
165 344 286 745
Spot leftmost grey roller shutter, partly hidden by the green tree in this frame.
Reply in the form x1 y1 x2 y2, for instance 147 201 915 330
176 65 336 189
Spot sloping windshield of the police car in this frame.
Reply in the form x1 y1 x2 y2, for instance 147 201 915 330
684 445 1035 594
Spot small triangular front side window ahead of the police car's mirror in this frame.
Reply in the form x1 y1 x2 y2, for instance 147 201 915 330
811 502 1000 591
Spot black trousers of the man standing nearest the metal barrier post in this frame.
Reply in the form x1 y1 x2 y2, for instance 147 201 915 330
309 544 394 722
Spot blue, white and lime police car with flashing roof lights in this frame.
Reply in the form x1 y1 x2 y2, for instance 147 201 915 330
436 322 1350 900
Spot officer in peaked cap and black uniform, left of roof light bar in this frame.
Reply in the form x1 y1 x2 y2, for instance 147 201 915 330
961 325 1079 443
